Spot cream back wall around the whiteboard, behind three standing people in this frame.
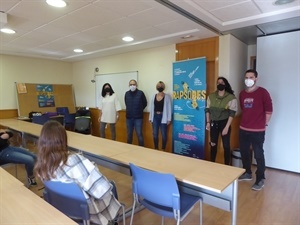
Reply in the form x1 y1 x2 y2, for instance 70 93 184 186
73 45 176 111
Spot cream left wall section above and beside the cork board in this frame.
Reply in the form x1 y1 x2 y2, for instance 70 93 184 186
0 55 72 109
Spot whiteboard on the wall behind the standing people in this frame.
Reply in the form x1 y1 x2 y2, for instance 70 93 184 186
95 71 138 109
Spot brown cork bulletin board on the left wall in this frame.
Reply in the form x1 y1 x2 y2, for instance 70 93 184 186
16 83 76 117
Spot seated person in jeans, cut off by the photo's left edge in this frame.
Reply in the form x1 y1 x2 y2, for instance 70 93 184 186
0 129 37 185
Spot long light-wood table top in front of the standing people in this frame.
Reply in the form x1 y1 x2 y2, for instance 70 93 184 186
0 119 244 193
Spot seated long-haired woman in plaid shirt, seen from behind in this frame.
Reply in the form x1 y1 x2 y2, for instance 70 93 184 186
35 120 121 224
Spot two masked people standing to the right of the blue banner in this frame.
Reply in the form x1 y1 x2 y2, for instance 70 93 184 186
205 69 273 191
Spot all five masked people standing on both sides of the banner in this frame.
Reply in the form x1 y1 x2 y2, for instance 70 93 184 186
100 69 273 190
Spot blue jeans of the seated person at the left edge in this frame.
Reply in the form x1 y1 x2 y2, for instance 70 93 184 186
0 146 36 177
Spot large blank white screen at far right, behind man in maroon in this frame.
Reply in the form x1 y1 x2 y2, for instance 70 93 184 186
256 31 300 173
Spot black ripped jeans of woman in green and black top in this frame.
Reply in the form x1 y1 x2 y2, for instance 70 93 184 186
210 119 231 165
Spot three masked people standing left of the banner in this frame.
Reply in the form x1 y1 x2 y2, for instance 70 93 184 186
99 79 172 150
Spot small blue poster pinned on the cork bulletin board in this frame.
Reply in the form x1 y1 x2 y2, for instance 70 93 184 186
36 84 55 108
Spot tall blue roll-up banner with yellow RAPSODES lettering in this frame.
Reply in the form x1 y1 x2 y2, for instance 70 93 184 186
173 58 206 159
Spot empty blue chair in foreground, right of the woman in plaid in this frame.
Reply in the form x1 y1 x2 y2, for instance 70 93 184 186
130 163 202 225
